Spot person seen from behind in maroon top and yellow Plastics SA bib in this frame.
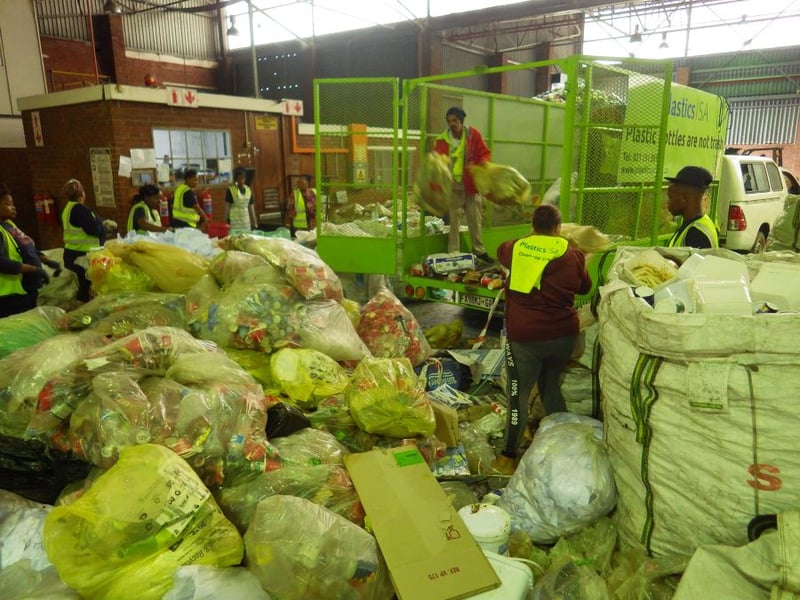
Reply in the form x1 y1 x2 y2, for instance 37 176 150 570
493 204 592 474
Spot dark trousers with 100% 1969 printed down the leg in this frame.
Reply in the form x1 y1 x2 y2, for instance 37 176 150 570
503 335 578 458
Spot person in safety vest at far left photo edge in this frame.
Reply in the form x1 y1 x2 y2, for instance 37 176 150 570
0 184 61 317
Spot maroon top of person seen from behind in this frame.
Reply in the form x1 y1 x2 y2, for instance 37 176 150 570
497 240 592 342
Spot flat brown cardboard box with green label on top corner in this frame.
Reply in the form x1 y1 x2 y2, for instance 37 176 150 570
344 446 500 600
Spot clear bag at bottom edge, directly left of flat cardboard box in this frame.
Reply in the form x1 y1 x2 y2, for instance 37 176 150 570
244 495 392 600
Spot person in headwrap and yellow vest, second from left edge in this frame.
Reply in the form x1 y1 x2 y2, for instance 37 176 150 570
61 179 106 302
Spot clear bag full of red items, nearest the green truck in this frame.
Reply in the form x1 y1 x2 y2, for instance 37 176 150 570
356 287 433 366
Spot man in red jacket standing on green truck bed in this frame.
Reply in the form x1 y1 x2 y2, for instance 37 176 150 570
433 106 492 262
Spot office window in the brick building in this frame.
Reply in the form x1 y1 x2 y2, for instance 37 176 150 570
153 129 233 186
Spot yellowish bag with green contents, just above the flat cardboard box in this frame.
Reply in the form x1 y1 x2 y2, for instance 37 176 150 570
345 358 436 438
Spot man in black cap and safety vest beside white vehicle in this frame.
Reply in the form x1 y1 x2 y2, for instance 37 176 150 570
667 166 719 248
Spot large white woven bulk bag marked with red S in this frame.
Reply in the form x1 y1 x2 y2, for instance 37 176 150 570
599 248 800 556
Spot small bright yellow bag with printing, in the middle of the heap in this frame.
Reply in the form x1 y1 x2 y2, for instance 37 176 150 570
270 348 350 410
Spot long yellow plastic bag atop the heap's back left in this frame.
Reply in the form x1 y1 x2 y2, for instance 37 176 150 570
106 240 208 294
